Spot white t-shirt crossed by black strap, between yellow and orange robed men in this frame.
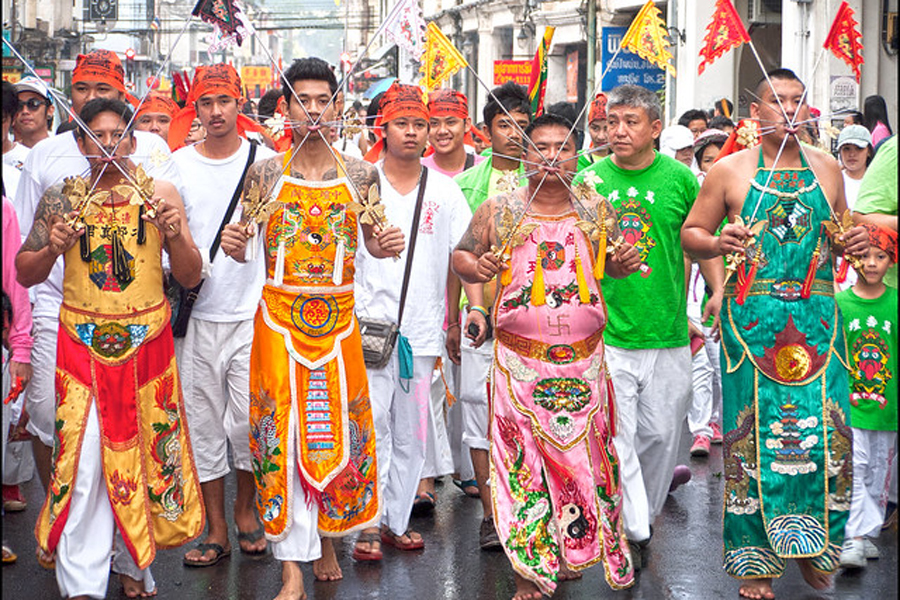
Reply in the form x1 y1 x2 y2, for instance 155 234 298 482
172 139 275 323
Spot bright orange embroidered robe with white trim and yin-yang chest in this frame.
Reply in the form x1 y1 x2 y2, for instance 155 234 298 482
250 168 380 541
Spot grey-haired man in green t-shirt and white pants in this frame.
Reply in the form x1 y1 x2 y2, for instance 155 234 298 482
575 85 724 567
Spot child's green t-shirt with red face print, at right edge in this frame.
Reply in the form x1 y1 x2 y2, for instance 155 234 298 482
835 288 897 431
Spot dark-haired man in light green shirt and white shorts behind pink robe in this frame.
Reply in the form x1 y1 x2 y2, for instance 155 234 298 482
448 81 531 550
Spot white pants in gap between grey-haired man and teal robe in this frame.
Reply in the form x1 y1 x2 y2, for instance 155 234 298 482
688 319 722 437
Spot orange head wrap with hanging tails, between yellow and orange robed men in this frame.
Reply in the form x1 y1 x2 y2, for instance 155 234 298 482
169 63 263 150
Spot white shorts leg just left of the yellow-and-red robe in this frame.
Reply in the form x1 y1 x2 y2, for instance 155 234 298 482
25 317 59 448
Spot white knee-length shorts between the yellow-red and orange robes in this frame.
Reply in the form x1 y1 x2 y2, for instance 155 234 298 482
175 319 253 483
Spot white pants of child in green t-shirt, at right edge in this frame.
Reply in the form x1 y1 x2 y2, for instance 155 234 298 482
844 427 897 538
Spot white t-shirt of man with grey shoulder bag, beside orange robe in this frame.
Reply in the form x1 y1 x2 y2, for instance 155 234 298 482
355 164 472 356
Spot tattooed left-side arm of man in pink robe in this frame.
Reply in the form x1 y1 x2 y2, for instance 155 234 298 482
451 197 502 283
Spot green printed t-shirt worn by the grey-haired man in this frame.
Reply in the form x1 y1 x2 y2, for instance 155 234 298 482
575 152 700 349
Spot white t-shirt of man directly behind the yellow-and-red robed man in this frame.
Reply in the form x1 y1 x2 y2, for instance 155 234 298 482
13 131 181 319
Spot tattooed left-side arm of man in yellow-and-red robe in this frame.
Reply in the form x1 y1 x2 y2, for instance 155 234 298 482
16 184 84 287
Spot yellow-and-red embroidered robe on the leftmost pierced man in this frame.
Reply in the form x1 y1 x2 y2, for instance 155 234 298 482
35 199 205 569
